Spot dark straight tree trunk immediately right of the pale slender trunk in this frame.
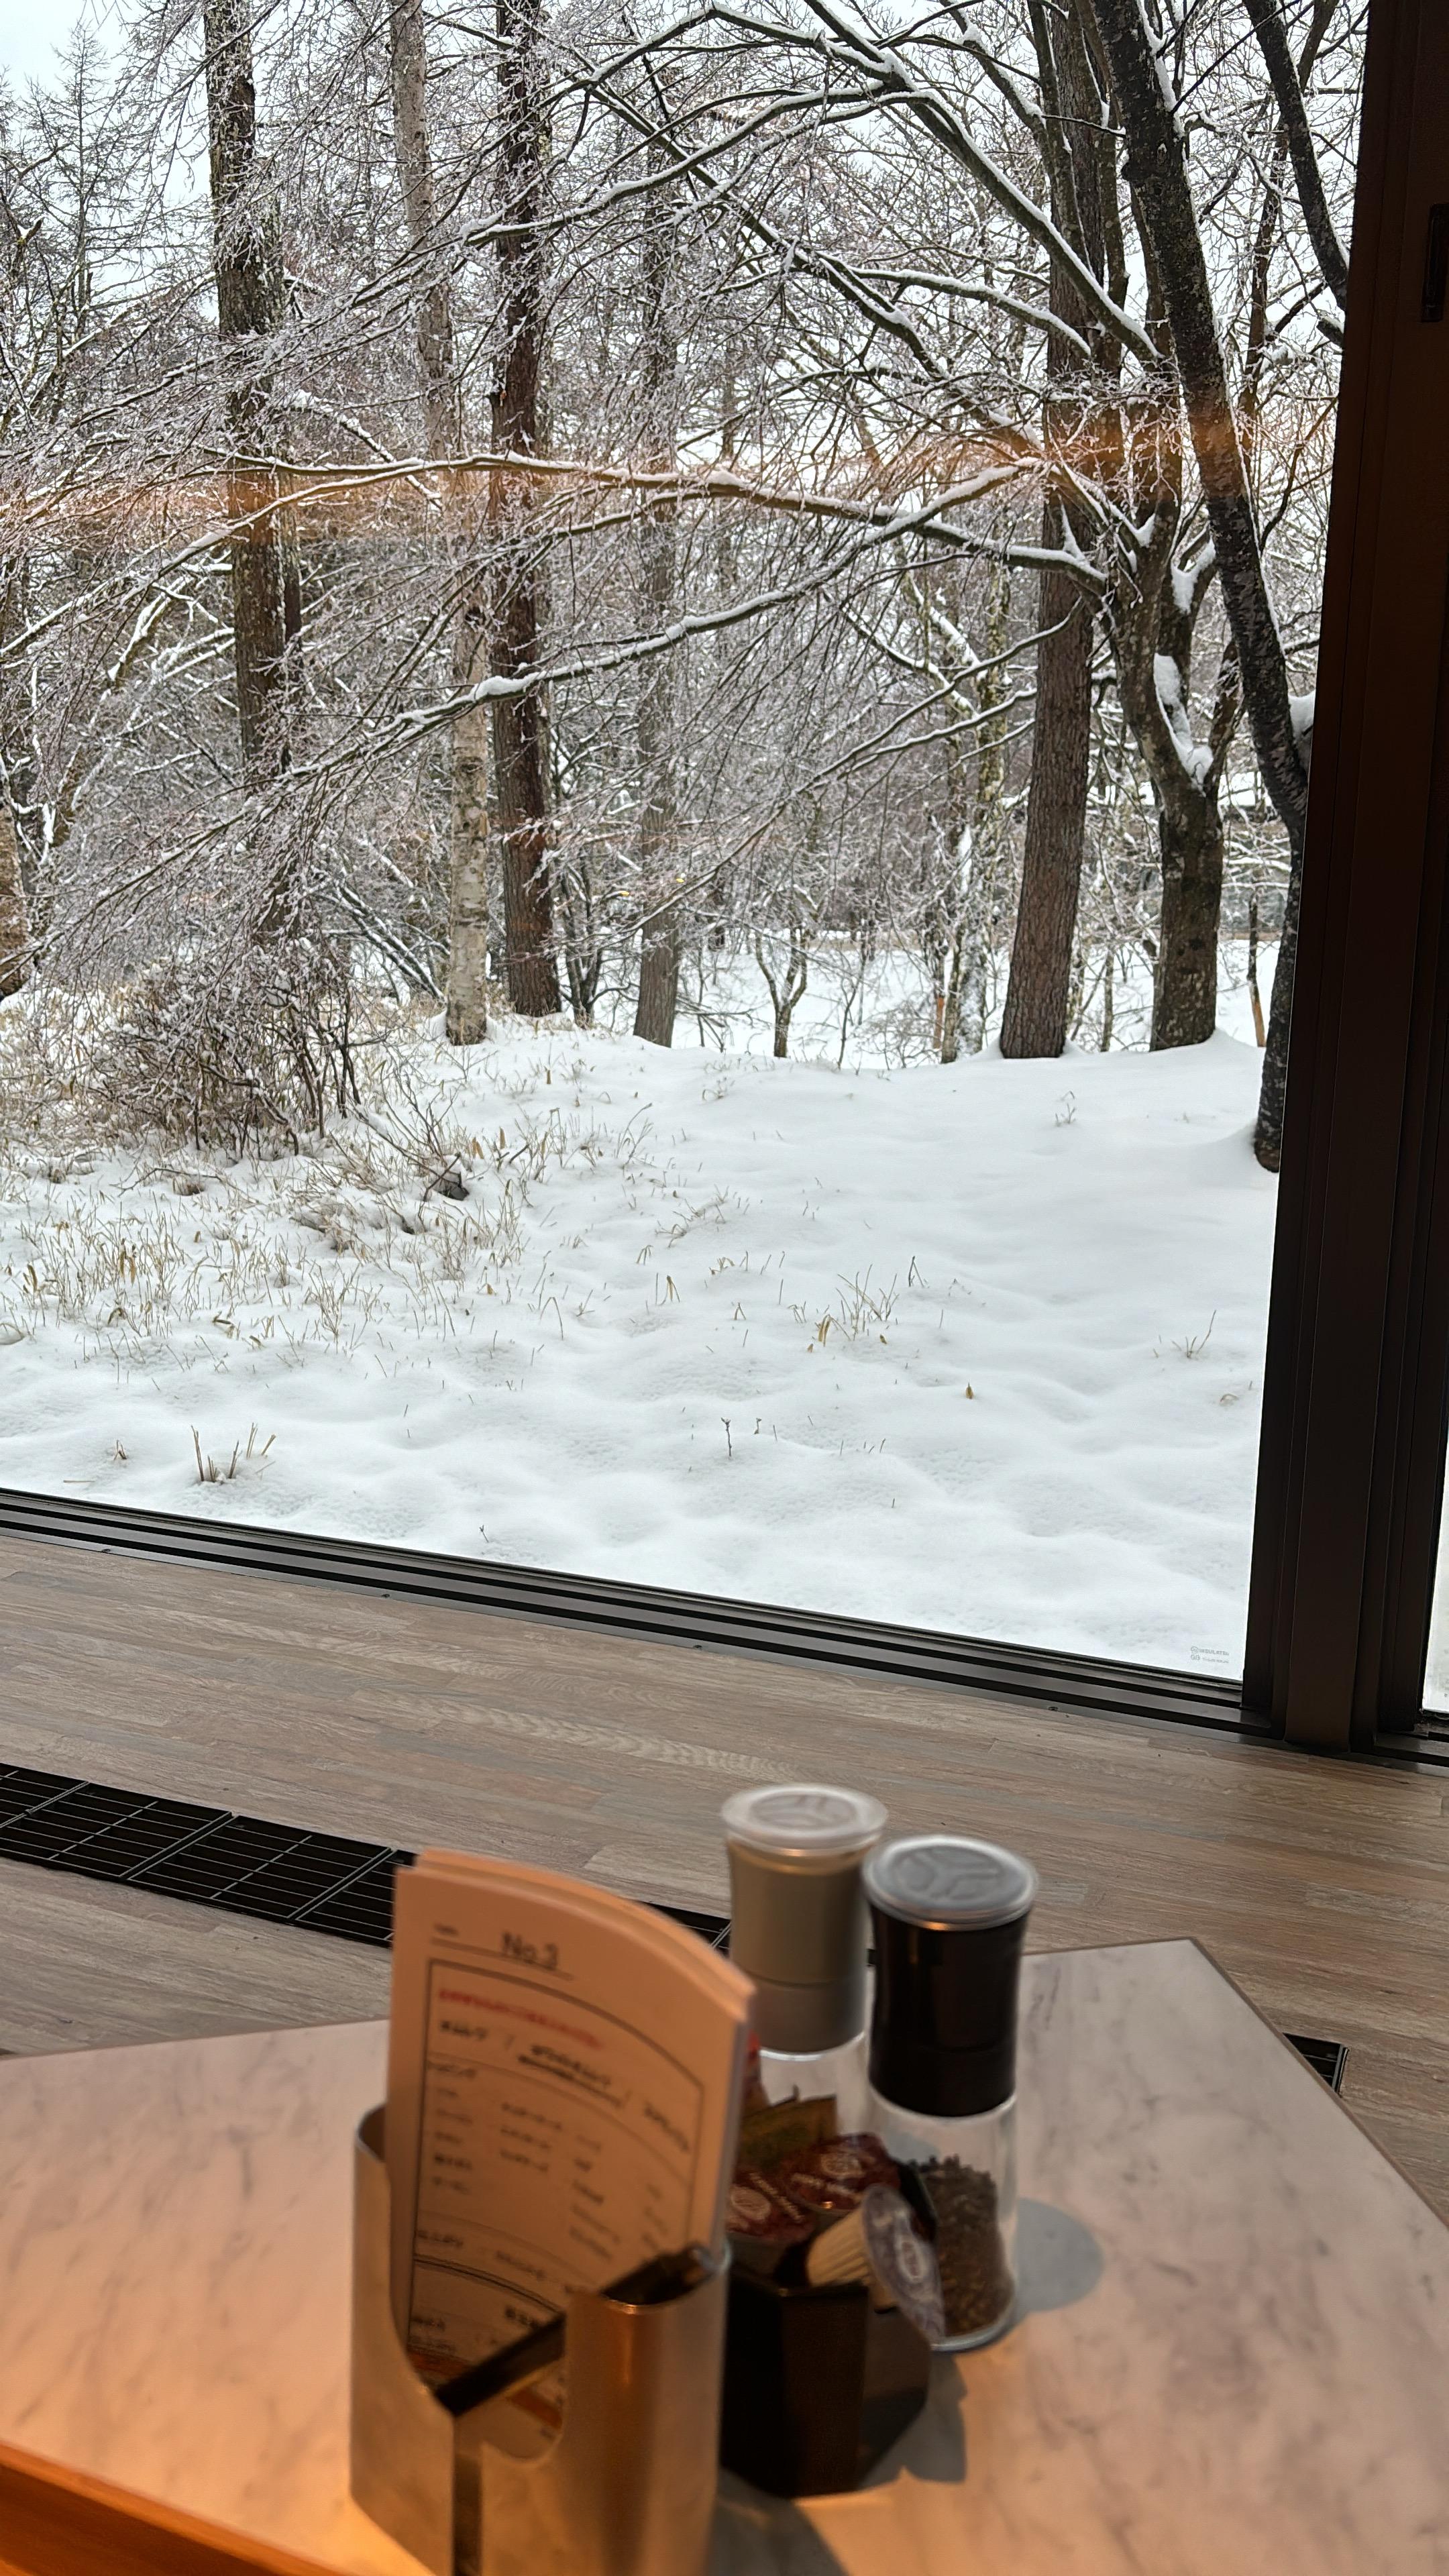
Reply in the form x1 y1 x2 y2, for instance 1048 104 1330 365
490 0 559 1020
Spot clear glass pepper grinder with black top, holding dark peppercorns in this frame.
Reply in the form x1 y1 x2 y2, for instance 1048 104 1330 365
864 1834 1036 2352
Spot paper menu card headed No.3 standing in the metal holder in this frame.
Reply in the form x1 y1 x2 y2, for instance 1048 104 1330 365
387 1852 753 2377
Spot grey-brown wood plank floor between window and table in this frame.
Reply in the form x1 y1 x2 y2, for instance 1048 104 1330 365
0 1540 1449 2215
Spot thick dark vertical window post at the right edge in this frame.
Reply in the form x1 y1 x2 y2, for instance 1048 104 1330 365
1243 0 1449 1752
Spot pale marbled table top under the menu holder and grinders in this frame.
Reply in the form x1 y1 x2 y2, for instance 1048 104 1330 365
0 1942 1449 2576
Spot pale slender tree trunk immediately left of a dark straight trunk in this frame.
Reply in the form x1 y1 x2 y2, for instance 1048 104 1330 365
387 0 490 1046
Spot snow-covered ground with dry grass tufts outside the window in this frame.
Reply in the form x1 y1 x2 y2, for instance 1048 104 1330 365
0 961 1274 1674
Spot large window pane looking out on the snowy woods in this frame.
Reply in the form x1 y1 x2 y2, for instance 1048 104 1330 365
0 0 1364 1674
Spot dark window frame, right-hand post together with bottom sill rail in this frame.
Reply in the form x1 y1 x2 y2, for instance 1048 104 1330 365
0 0 1449 1757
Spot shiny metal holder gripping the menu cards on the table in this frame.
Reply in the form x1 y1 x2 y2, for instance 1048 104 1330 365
351 2107 727 2576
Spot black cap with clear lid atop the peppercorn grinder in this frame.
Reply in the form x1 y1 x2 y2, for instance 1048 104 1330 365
864 1834 1036 2120
